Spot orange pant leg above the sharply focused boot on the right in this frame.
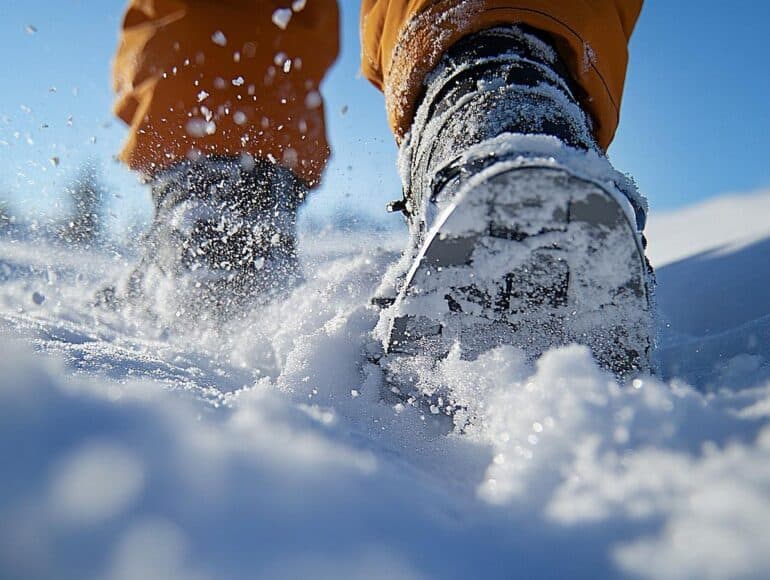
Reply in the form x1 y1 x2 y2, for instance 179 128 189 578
361 0 643 149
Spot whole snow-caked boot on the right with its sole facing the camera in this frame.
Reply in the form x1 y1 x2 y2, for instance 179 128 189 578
376 27 654 413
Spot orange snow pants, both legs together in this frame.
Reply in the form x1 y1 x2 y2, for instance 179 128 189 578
113 0 643 186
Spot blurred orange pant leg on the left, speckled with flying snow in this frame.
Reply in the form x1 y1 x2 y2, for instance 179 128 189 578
113 0 339 185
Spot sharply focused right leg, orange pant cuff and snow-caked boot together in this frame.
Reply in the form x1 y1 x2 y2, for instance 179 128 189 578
362 0 653 402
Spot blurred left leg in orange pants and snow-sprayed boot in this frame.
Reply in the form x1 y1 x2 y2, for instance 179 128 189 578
106 0 339 316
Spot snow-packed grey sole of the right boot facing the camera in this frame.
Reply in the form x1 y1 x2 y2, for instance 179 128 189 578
381 166 654 408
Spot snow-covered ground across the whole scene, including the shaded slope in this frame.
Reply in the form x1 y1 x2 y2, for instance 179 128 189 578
0 193 770 580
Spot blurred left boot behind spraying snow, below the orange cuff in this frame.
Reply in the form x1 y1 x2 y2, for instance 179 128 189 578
97 157 307 320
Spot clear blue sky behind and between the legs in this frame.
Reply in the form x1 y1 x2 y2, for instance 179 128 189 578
0 0 770 233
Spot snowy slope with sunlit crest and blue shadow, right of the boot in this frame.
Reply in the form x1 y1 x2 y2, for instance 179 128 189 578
647 192 770 390
